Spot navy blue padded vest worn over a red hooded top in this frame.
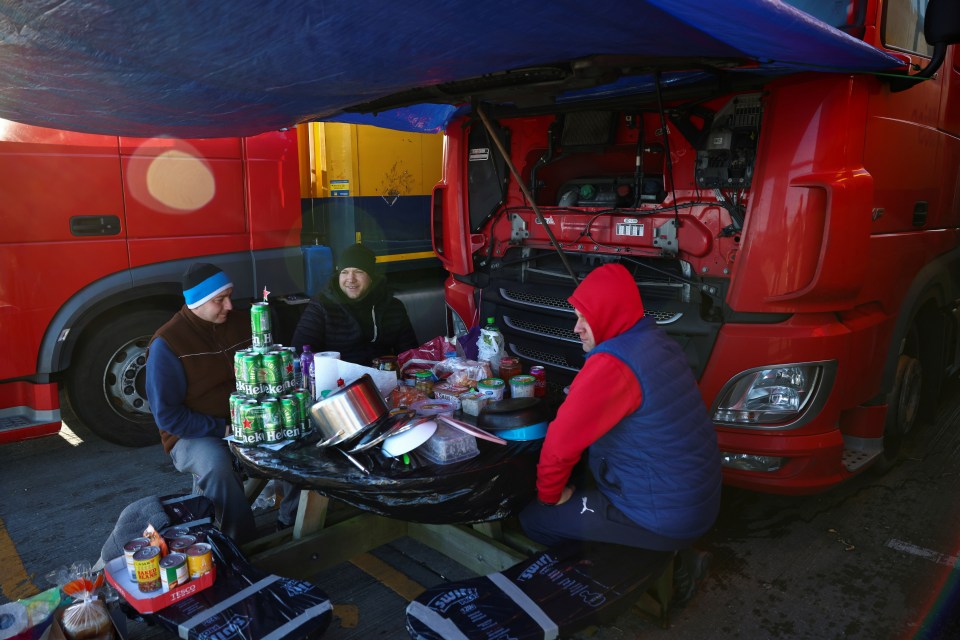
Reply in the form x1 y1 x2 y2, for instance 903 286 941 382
588 318 721 538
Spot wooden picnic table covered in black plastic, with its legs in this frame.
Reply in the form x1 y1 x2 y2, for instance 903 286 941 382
231 424 542 577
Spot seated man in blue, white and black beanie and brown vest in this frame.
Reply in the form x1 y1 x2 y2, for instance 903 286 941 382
146 263 256 544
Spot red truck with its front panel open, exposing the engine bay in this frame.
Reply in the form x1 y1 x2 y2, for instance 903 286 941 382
433 0 960 494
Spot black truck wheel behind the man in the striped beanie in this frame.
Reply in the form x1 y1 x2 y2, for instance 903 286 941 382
67 309 173 447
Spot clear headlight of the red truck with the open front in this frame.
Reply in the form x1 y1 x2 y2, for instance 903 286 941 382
713 360 836 429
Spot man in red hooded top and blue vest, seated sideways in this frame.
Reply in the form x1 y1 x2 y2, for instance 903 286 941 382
520 264 721 600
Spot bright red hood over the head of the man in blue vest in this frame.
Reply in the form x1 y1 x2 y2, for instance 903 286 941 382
567 264 643 344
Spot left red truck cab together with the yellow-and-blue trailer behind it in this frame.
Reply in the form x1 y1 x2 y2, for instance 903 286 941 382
0 120 443 446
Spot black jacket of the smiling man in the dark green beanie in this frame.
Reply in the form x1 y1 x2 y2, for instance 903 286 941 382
292 274 418 367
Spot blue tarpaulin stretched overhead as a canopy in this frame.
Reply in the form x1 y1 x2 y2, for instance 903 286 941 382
0 0 902 137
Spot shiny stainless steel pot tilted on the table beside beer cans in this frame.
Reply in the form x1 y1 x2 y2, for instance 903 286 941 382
310 374 389 446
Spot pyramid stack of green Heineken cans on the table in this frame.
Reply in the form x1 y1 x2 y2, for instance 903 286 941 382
230 301 310 445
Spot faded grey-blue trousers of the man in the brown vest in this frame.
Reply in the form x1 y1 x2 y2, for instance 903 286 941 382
170 438 257 544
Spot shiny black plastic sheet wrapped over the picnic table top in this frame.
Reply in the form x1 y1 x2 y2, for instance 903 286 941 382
230 435 542 524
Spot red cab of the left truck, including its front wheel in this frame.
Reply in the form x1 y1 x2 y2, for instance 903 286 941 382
0 121 304 445
